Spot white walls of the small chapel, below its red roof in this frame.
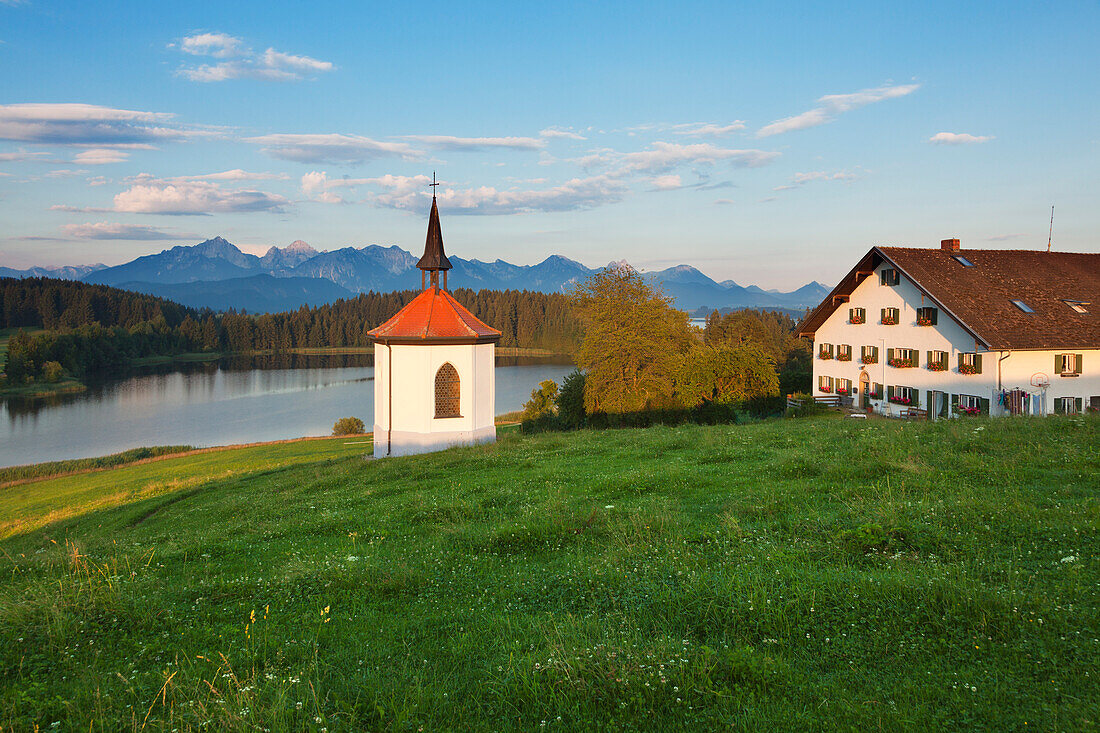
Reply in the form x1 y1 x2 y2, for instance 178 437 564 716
374 343 496 458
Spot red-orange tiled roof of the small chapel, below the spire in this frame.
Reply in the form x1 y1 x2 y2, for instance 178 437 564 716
367 287 501 343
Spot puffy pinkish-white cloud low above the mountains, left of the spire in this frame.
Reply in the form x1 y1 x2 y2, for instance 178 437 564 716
114 177 288 215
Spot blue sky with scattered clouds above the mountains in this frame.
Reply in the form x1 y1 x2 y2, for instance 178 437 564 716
0 0 1100 288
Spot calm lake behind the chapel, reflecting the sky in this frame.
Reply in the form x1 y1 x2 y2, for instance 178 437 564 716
0 354 573 466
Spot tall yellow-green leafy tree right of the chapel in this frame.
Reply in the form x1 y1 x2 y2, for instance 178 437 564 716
571 266 695 414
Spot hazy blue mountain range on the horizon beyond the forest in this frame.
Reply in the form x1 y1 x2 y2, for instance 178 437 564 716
0 237 829 313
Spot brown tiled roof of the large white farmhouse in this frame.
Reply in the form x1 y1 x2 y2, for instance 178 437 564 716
800 247 1100 351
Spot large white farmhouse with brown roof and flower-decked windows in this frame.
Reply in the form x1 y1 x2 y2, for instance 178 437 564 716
799 239 1100 418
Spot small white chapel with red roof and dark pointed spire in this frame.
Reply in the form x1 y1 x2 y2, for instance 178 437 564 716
367 196 501 458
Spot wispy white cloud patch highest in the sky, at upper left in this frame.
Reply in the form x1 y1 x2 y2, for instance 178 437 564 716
172 33 333 81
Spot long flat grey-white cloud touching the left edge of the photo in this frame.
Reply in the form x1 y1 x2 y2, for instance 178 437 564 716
0 103 202 150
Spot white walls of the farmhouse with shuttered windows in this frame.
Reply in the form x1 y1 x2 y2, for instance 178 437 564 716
813 263 1100 415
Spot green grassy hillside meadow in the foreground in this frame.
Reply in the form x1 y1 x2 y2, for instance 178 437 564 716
0 417 1100 731
